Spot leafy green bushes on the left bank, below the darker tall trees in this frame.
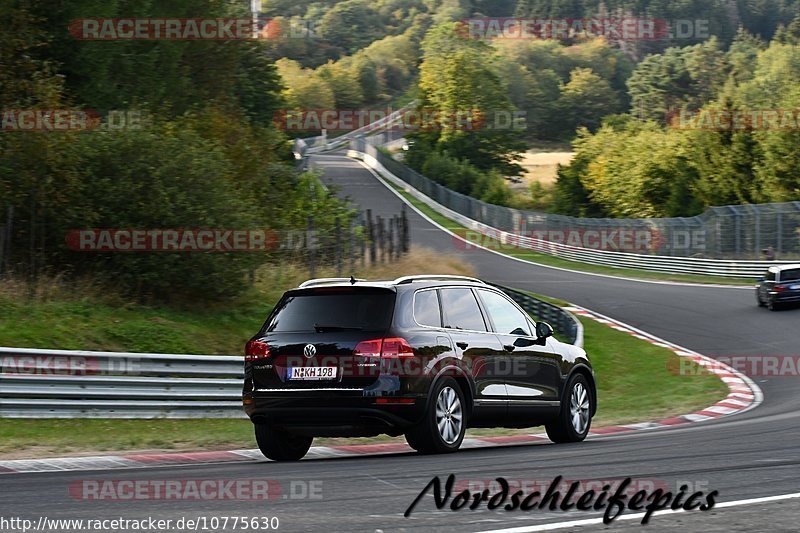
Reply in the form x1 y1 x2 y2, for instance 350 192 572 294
0 120 352 301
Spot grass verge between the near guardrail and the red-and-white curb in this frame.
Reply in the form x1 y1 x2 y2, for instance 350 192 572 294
0 308 727 459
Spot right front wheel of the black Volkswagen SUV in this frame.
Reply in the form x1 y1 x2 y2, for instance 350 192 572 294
545 374 595 443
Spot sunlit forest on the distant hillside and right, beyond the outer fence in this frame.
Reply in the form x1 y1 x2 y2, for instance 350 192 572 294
265 0 800 217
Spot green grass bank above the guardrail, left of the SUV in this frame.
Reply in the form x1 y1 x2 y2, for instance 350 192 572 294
0 284 277 355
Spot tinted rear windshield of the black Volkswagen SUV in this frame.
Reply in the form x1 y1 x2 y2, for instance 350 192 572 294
265 288 395 332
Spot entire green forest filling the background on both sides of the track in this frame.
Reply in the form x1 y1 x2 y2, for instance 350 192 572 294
0 0 800 298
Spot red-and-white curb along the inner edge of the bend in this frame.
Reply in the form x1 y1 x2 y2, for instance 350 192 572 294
0 306 763 474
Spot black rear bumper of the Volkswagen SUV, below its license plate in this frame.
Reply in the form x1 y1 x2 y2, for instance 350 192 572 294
243 390 426 437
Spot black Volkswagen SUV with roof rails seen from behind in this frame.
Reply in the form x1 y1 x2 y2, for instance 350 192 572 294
243 276 597 461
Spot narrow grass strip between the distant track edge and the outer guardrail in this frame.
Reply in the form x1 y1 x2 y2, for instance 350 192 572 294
384 178 755 286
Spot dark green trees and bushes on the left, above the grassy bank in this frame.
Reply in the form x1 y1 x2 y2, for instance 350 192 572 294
0 0 351 300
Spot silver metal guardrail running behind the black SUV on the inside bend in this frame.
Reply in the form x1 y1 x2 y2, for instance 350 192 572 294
0 287 583 418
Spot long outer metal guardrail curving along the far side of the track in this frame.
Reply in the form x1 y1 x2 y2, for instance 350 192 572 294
349 139 798 279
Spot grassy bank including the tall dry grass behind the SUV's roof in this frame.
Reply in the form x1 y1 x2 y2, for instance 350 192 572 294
0 249 475 355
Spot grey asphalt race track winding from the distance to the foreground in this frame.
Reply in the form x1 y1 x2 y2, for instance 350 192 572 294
0 155 800 532
